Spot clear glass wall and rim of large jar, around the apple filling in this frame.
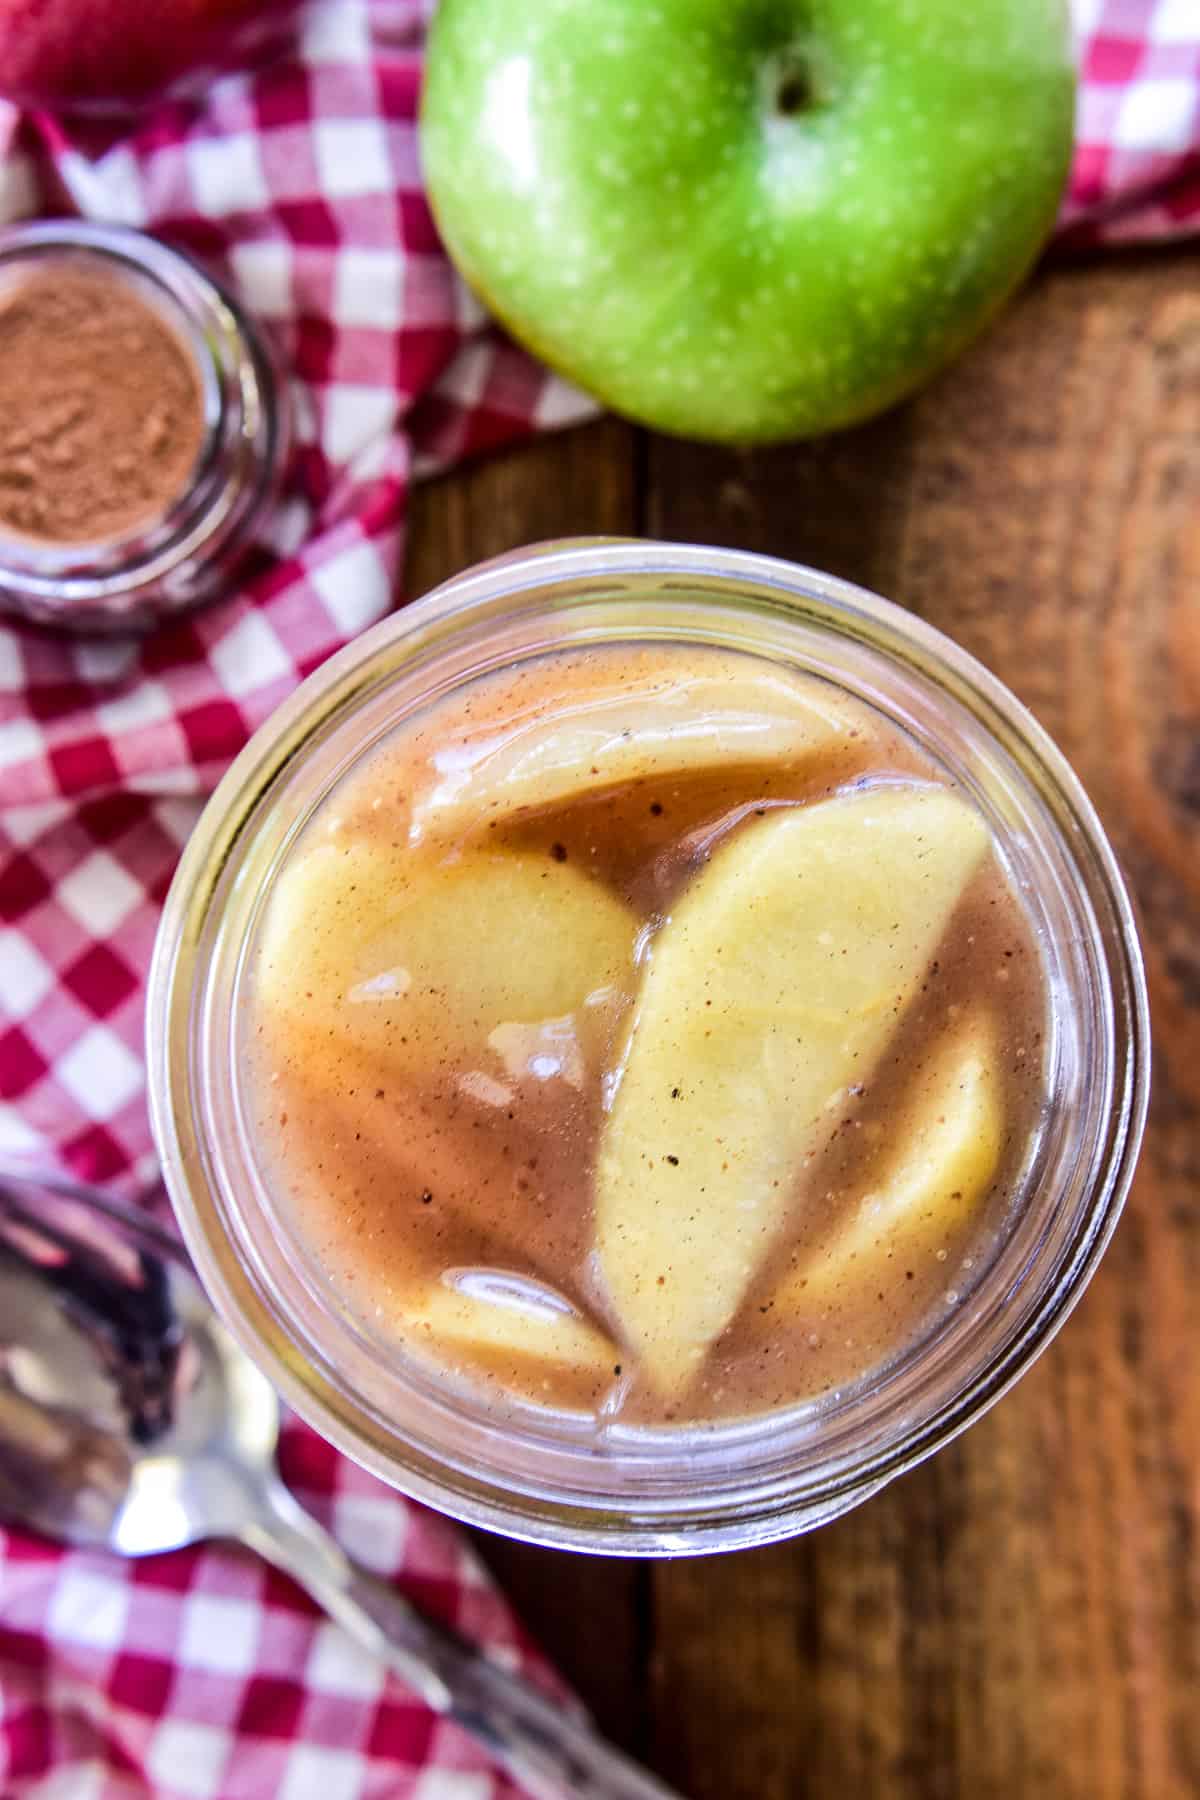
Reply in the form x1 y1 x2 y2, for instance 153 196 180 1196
148 542 1150 1555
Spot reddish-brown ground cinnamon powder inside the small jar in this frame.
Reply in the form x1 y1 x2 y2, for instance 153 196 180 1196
0 265 205 544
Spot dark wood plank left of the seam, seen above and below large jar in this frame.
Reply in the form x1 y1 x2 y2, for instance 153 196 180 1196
407 408 649 1751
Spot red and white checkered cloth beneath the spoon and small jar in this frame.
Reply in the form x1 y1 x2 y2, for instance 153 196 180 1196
0 0 1200 1800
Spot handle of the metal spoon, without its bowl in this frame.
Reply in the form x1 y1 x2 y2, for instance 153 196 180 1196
237 1480 680 1800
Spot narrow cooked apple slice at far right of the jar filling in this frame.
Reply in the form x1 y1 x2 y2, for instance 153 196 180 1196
765 1012 1004 1327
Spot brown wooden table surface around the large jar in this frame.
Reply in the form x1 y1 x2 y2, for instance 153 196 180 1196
408 250 1200 1800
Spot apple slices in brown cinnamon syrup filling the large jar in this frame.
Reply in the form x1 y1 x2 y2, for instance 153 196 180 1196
245 646 1045 1424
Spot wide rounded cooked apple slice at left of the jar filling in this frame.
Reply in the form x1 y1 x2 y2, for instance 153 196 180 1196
259 839 639 1071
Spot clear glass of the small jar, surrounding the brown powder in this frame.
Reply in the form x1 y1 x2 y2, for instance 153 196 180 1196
0 220 290 632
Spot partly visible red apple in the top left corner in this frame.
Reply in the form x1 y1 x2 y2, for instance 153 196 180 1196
0 0 290 108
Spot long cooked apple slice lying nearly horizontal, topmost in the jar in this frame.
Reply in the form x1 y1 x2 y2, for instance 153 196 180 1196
410 662 871 842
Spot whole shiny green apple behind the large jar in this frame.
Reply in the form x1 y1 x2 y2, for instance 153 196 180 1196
421 0 1074 443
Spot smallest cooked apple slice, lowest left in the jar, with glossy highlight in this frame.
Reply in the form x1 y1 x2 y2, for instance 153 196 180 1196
403 1269 621 1381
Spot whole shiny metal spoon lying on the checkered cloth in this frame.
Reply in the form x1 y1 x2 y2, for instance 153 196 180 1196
0 1170 678 1800
